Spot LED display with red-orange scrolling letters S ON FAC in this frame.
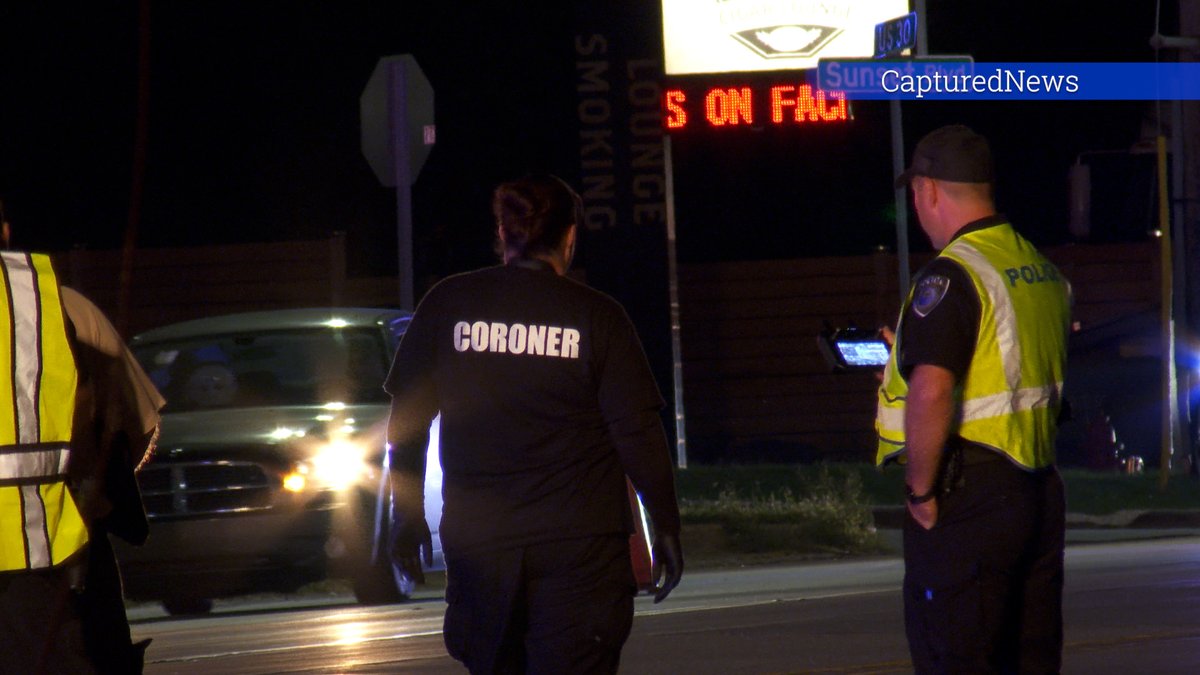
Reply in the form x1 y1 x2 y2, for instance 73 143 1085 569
662 83 853 131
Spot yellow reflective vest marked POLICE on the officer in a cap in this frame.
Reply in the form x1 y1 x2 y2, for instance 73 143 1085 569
875 223 1070 470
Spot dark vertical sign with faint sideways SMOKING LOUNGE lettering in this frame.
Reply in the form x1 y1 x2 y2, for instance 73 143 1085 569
572 0 672 425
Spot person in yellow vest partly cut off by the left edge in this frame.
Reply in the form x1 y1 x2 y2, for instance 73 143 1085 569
0 200 163 674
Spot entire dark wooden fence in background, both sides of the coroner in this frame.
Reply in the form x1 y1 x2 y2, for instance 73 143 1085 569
54 235 1160 461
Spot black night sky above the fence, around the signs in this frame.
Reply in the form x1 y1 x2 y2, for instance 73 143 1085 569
0 0 1177 277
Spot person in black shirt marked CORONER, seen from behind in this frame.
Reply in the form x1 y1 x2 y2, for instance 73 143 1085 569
385 175 683 674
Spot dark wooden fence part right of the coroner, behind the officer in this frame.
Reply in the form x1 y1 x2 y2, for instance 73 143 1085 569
679 243 1160 461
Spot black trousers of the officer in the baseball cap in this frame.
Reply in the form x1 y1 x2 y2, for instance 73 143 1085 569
904 458 1066 675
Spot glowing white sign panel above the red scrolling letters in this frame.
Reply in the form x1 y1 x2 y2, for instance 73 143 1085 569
662 0 908 74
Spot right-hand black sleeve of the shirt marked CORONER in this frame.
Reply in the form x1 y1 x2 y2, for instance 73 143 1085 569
596 302 679 534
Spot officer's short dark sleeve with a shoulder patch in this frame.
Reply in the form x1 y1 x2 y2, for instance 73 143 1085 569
898 258 980 382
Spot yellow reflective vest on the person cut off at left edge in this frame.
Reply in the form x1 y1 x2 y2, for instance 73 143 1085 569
0 252 88 572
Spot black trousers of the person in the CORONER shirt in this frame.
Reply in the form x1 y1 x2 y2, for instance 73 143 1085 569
444 534 636 675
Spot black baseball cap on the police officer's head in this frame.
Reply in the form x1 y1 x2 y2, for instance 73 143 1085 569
894 124 994 190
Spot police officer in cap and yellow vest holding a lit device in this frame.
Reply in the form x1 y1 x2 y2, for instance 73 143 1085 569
876 125 1070 674
